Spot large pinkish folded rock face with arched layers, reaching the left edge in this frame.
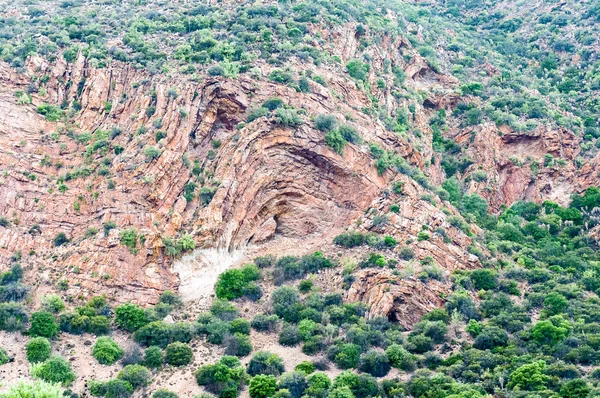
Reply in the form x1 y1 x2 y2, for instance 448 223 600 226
0 52 422 302
